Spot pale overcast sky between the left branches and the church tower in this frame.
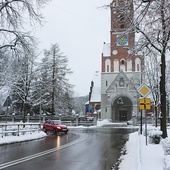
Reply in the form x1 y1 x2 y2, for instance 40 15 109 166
36 0 111 96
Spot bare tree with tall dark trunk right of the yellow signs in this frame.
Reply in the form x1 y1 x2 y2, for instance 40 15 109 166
132 0 170 138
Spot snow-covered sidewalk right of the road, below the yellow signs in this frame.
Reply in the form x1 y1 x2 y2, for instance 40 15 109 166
119 127 170 170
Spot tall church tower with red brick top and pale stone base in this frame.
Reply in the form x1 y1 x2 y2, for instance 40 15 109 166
101 0 143 121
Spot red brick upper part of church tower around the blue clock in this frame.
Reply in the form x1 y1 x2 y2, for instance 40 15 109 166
101 0 139 72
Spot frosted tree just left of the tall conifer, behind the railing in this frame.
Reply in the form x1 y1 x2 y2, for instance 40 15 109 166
8 51 35 122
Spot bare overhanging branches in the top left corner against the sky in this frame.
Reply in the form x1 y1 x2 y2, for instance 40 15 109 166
0 0 48 56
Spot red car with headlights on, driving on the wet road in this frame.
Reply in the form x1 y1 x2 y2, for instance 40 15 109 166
43 120 68 134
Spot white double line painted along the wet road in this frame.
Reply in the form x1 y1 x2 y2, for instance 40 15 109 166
0 137 89 169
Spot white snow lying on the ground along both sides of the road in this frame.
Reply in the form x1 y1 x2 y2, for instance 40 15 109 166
0 120 170 170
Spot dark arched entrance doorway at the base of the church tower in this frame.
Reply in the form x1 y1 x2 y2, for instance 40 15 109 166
112 96 133 121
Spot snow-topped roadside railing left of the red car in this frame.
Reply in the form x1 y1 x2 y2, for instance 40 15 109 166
0 123 41 138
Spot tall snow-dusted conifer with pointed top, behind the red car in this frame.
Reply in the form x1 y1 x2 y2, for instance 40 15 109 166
33 44 72 115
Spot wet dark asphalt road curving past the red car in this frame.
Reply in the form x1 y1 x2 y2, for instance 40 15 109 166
0 128 133 170
